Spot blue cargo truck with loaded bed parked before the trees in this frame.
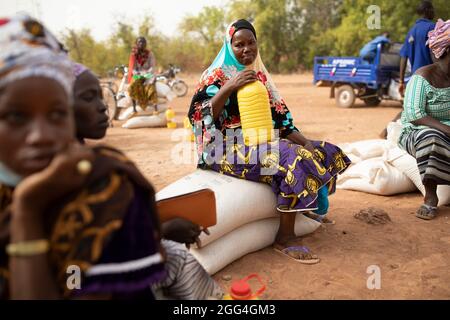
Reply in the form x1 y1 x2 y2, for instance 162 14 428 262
314 43 406 108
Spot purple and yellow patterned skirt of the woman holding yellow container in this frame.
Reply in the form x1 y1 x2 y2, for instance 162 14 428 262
206 139 351 212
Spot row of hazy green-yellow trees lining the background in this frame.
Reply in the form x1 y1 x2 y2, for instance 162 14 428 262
62 0 450 75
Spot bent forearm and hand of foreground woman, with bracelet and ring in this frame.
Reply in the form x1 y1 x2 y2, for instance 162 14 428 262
9 144 94 299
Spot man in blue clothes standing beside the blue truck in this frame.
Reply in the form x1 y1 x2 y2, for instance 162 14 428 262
399 0 435 96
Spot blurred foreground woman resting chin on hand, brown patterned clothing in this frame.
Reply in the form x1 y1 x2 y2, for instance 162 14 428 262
0 16 166 299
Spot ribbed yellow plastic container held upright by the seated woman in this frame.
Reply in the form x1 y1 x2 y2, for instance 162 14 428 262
237 81 273 145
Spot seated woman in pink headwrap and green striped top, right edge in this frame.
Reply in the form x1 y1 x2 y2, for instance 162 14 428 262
399 19 450 220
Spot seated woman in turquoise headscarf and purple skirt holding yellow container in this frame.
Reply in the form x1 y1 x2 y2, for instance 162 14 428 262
189 20 350 263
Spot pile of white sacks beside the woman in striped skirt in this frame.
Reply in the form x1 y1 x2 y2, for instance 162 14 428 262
337 122 450 205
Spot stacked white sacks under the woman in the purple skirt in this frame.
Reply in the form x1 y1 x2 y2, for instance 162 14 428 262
156 169 320 274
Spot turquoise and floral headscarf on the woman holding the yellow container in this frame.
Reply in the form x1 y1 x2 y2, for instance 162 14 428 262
199 19 284 109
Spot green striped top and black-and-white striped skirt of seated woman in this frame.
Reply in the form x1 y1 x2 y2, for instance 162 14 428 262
399 75 450 185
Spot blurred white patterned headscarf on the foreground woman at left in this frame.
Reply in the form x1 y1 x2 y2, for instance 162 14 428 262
0 15 74 187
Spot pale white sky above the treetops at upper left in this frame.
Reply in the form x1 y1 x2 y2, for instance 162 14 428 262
0 0 229 40
